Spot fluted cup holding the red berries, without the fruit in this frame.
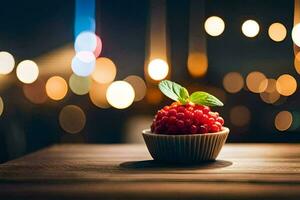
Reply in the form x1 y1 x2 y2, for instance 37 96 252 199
143 127 229 163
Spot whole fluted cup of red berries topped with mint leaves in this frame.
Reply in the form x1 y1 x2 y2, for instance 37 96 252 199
142 80 229 163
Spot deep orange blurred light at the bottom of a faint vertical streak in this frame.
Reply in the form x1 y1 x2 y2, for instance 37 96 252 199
187 53 208 77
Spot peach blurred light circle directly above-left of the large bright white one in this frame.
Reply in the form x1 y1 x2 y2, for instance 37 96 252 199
92 57 117 83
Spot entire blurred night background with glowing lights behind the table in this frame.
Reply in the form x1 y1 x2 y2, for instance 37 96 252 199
0 0 300 162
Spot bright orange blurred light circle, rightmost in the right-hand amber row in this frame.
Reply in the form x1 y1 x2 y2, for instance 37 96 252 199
276 74 297 96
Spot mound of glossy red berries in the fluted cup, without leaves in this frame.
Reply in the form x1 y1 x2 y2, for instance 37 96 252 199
151 102 224 134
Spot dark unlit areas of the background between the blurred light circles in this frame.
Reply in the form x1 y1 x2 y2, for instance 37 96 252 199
0 0 300 162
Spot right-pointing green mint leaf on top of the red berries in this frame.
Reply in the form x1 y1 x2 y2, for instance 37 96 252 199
189 92 224 106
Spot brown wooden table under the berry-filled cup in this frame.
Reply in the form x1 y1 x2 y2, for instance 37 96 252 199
0 144 300 200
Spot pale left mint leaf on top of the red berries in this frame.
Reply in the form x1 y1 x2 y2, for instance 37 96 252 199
158 80 189 104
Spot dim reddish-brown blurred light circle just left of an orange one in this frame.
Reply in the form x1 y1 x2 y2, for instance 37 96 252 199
23 79 48 104
